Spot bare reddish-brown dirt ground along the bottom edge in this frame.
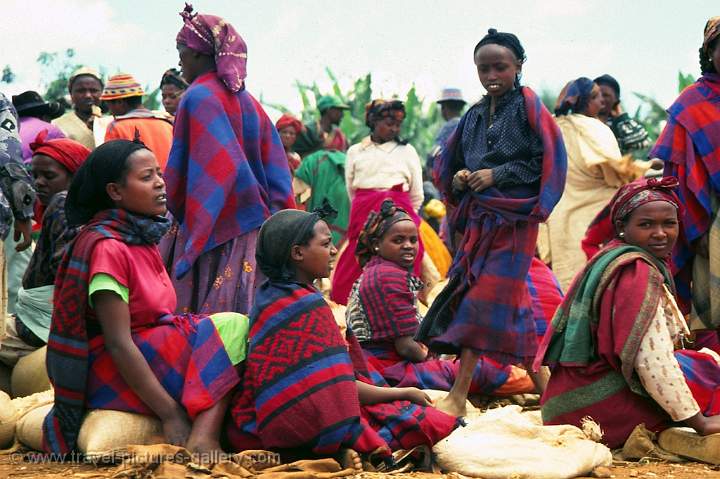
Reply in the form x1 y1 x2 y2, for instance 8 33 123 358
0 453 720 479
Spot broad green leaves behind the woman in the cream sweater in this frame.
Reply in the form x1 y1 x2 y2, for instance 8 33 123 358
272 68 442 158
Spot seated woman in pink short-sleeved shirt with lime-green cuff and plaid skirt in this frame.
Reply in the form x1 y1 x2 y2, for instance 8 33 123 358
43 140 243 453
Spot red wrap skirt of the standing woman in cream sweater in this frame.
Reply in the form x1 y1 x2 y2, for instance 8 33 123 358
330 185 425 304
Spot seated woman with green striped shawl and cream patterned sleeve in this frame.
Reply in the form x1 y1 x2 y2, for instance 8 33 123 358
535 177 720 448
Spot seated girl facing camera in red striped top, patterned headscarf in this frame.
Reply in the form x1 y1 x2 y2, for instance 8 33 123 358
346 200 534 394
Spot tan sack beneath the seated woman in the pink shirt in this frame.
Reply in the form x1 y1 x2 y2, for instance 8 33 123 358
78 409 164 459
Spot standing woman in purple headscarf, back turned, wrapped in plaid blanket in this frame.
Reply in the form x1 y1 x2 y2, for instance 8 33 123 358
162 6 295 313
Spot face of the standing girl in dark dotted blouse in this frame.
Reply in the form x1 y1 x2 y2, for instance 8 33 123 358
475 44 522 97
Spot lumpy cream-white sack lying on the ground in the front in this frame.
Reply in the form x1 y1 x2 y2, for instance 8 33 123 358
433 406 612 479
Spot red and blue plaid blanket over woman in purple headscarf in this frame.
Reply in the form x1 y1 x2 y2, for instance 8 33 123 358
165 72 295 278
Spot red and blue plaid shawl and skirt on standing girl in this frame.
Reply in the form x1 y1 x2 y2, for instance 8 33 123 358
417 87 567 365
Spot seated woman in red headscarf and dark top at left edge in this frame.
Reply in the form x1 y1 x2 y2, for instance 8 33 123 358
0 130 90 366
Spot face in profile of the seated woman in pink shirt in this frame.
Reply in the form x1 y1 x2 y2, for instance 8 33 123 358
107 149 167 216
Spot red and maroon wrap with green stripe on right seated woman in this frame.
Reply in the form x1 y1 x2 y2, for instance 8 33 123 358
536 241 671 448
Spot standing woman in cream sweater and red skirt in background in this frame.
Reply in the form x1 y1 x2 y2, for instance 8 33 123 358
330 100 424 304
